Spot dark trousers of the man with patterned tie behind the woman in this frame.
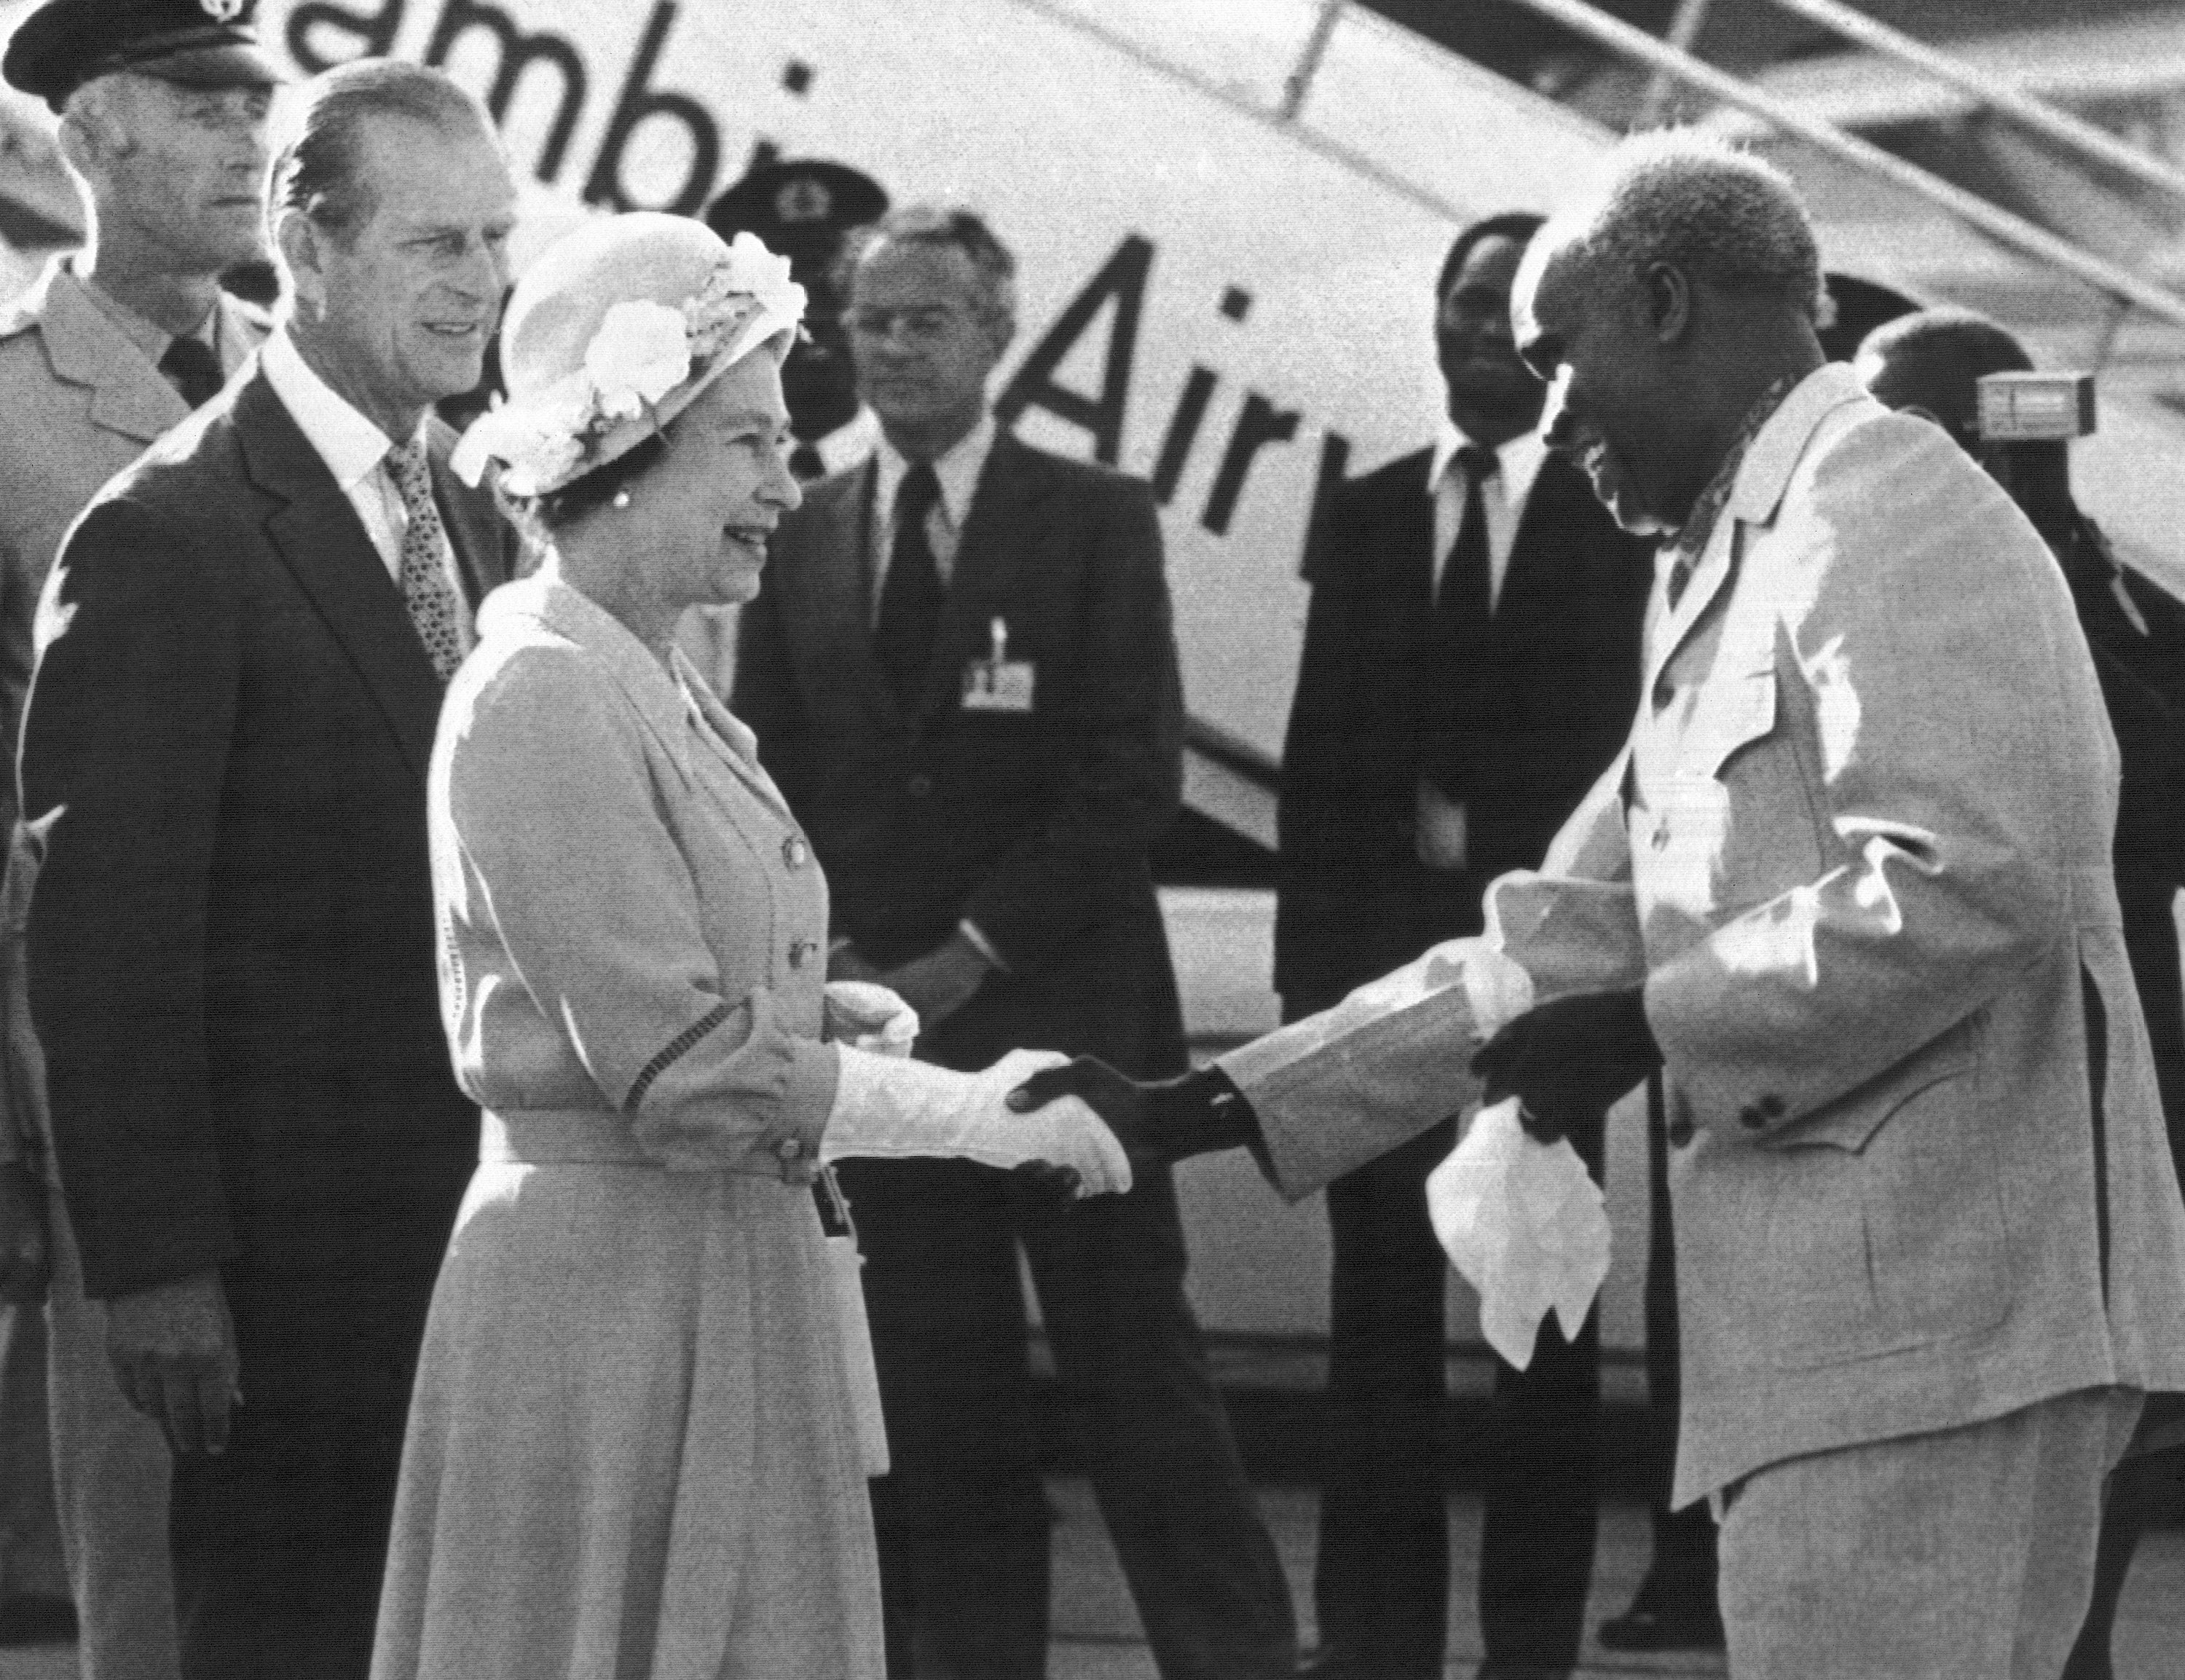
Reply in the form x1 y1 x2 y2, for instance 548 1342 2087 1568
168 1278 424 1680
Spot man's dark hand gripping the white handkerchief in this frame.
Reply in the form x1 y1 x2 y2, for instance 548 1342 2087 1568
1473 987 1661 1143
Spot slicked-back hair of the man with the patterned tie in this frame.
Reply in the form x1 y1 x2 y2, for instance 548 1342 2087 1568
267 59 496 249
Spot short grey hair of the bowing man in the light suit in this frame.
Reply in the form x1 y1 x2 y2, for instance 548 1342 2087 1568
1540 129 1827 321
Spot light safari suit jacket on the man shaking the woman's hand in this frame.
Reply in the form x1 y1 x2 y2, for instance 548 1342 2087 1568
1221 367 2185 1505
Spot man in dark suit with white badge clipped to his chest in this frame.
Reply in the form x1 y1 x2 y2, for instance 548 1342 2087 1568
736 212 1296 1680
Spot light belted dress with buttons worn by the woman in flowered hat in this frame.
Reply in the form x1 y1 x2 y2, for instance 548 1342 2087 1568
371 575 883 1680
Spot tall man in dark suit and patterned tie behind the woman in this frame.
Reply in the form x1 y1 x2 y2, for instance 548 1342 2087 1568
22 61 513 1680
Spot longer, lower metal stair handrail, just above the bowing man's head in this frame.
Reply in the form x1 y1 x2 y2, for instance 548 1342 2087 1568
1516 0 2185 326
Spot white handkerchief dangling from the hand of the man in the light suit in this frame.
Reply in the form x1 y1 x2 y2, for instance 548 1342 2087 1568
1427 1097 1608 1370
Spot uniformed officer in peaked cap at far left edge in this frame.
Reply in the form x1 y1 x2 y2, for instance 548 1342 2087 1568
0 0 280 1680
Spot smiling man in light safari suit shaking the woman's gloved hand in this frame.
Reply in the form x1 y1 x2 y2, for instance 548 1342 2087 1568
1023 135 2185 1680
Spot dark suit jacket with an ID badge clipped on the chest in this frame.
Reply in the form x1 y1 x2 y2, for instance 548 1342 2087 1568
734 433 1184 1073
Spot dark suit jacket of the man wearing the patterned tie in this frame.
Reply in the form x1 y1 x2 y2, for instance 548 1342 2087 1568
22 371 513 1311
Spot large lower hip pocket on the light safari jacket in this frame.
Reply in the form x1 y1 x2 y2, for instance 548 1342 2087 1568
1748 1018 2010 1370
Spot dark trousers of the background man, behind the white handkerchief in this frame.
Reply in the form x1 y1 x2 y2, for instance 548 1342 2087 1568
1313 1121 1602 1680
